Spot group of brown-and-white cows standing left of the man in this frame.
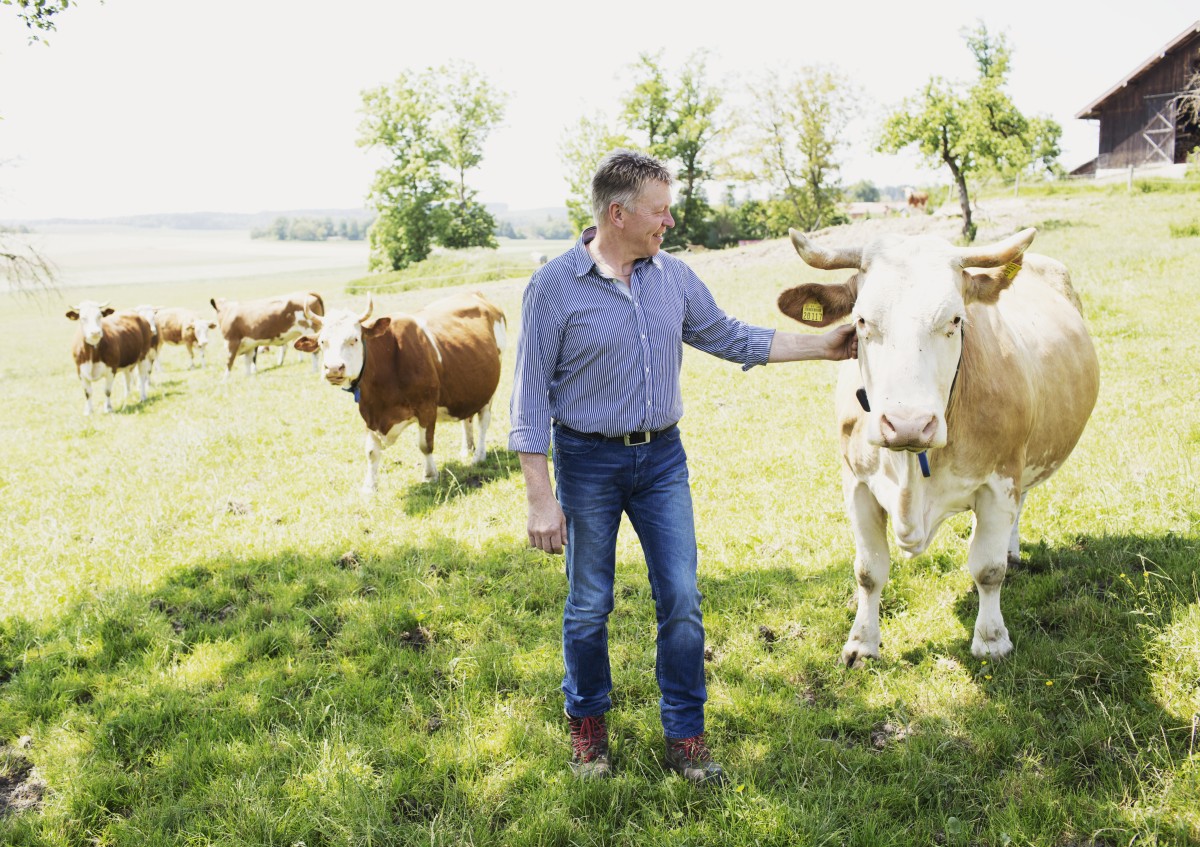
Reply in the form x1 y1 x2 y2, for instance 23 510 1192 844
67 292 505 492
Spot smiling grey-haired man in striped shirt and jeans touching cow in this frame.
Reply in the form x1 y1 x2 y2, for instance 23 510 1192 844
509 150 857 783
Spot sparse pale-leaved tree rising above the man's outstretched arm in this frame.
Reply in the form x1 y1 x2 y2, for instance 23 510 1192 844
749 66 858 230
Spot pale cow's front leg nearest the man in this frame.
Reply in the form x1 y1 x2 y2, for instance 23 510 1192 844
841 480 892 667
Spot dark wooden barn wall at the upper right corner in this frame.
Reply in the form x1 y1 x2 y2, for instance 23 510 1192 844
1097 34 1200 168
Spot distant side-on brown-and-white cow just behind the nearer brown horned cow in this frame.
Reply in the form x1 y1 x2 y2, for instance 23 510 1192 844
210 292 325 379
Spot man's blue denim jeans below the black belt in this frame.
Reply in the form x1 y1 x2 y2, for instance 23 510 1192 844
554 426 708 738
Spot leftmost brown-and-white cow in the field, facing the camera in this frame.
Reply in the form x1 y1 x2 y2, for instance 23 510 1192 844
67 300 151 415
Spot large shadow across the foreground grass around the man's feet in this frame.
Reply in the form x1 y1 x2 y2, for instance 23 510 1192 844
0 525 1196 847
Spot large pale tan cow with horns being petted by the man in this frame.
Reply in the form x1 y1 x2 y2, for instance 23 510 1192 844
779 229 1099 666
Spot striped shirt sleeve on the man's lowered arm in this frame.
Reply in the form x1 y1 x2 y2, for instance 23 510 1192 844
509 272 564 453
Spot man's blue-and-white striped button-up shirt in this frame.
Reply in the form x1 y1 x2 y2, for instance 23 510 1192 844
509 227 775 453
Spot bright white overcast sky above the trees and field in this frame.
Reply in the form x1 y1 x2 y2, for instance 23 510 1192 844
0 0 1200 220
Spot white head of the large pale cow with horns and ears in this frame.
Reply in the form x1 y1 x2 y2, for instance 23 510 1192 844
779 229 1036 451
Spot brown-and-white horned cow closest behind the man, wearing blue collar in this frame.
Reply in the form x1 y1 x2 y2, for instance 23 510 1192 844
295 293 505 493
